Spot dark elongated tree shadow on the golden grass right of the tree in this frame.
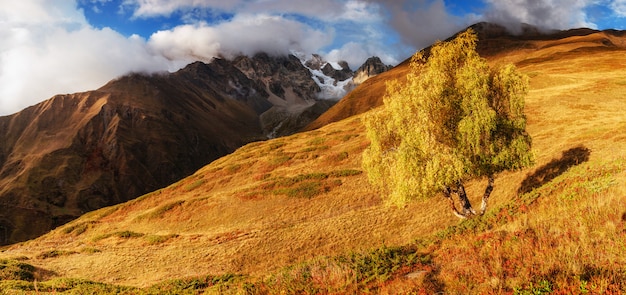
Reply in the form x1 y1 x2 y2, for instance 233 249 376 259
517 145 591 194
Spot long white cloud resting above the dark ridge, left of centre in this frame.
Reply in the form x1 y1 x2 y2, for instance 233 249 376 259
149 14 333 61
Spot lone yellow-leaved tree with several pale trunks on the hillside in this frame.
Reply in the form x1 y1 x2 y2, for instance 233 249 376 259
363 29 534 218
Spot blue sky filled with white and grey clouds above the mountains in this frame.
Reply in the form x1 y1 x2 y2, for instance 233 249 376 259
0 0 626 116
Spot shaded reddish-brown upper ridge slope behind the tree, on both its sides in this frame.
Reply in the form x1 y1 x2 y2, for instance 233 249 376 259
304 23 626 130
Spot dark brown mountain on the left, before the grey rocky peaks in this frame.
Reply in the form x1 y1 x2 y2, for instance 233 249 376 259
0 63 271 243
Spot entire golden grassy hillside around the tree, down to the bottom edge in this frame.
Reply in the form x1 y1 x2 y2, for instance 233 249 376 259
0 29 626 294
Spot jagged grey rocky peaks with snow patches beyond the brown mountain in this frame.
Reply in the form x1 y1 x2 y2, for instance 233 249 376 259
232 53 390 138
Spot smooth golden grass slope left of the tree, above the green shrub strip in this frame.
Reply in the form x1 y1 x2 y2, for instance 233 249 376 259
3 117 455 286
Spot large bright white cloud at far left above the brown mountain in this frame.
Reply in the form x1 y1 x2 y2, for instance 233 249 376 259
0 0 179 115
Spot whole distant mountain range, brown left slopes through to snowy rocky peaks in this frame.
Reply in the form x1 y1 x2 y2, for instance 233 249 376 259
0 53 390 244
